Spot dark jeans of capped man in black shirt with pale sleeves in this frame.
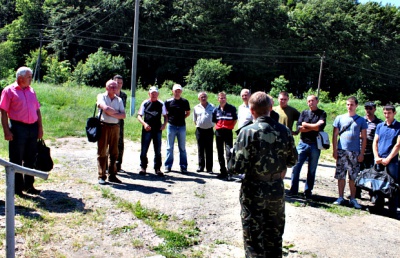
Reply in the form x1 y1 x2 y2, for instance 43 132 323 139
140 128 162 170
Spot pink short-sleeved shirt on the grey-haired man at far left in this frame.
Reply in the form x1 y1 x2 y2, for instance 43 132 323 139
0 82 40 124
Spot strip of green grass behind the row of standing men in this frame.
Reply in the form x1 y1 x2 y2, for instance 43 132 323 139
0 83 399 157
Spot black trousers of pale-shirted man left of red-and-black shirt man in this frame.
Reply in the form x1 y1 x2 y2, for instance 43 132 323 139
196 127 214 171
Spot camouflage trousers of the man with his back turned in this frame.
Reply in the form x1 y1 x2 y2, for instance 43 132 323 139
240 180 285 258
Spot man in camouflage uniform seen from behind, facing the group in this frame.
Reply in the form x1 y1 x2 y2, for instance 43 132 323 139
229 92 297 257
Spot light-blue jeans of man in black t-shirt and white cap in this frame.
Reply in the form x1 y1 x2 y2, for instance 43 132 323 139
164 124 187 170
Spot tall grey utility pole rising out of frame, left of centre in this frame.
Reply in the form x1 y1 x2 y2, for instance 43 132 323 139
130 0 140 116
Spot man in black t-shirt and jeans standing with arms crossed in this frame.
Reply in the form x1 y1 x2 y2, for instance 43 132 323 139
288 95 326 198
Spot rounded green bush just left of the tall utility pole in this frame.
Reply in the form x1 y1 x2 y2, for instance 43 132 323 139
72 48 127 87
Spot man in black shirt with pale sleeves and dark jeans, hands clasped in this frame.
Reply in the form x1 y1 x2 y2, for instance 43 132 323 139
138 86 167 176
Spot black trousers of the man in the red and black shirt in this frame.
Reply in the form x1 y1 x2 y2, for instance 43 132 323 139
215 129 233 174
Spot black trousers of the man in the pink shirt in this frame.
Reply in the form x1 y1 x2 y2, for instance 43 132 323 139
8 120 39 193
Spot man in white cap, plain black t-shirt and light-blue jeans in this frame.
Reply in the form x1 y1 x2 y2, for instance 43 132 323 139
164 84 190 174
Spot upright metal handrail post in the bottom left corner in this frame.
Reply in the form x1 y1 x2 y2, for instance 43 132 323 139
6 166 15 258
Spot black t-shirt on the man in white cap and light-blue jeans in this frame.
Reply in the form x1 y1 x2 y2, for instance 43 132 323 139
165 98 190 126
